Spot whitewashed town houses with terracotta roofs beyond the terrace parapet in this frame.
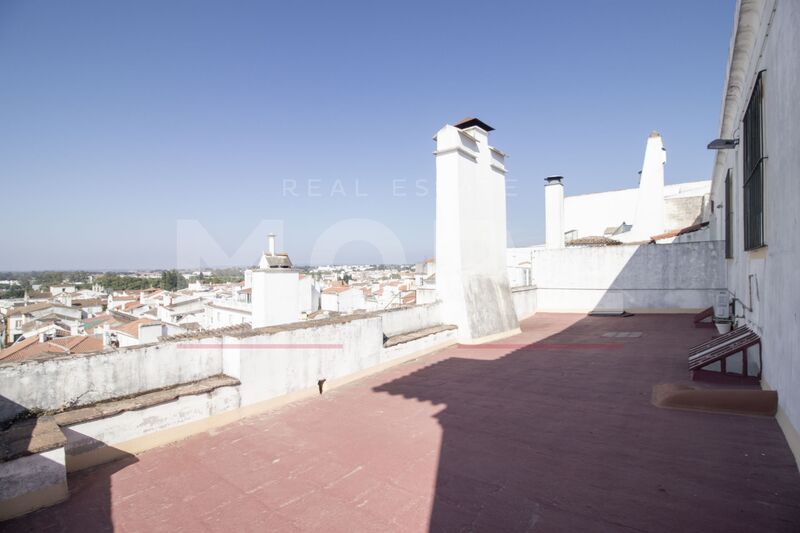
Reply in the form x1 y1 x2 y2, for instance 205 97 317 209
0 235 424 362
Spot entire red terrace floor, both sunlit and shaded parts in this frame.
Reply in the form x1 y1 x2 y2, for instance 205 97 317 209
6 314 800 532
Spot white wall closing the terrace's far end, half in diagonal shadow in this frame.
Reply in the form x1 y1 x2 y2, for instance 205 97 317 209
533 241 725 312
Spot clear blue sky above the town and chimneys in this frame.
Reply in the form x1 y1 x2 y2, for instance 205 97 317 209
0 0 734 270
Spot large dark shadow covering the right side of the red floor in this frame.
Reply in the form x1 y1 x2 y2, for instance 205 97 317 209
374 315 800 532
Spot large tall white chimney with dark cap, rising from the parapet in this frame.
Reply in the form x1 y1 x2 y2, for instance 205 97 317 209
434 119 519 342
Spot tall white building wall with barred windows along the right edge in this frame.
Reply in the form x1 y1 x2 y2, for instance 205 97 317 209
711 0 800 460
